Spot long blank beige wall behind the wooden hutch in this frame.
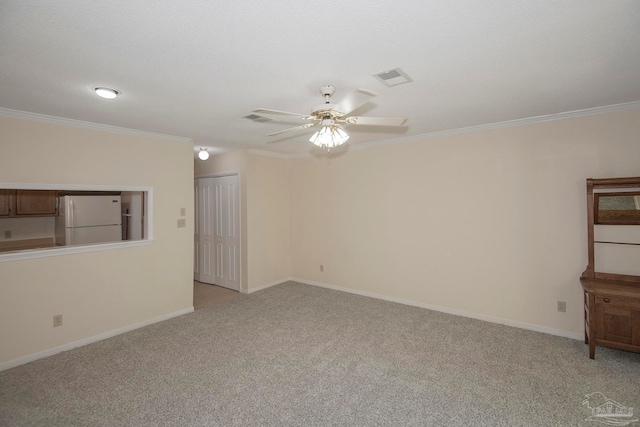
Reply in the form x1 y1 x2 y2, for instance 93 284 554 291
290 109 640 336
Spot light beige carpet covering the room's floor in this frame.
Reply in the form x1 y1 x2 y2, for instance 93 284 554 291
0 282 640 426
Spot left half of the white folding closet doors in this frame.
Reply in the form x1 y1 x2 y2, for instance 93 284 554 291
194 178 215 283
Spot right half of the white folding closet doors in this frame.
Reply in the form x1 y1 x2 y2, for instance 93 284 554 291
213 175 240 291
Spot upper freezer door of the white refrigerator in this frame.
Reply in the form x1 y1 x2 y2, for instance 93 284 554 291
64 196 122 227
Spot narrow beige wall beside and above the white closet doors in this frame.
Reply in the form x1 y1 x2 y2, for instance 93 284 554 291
194 150 291 292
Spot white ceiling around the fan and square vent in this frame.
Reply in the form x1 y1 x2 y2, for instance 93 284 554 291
0 0 640 154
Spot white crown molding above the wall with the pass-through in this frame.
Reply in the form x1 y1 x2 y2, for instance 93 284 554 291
0 107 193 144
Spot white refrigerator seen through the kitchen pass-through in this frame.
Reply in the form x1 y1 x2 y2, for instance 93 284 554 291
55 195 122 246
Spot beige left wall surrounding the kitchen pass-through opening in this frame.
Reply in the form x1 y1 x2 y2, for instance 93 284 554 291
0 117 193 363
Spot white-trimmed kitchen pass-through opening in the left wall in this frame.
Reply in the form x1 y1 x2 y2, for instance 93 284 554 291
0 187 152 257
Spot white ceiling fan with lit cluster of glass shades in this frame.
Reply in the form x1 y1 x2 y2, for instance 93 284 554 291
253 85 407 150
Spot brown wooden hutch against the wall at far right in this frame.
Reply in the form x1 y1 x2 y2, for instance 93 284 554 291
580 177 640 359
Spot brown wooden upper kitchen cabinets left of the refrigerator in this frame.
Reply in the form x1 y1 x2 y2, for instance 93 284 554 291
0 189 56 217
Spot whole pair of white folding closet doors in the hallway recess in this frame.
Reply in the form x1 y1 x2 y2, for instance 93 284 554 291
194 175 240 291
